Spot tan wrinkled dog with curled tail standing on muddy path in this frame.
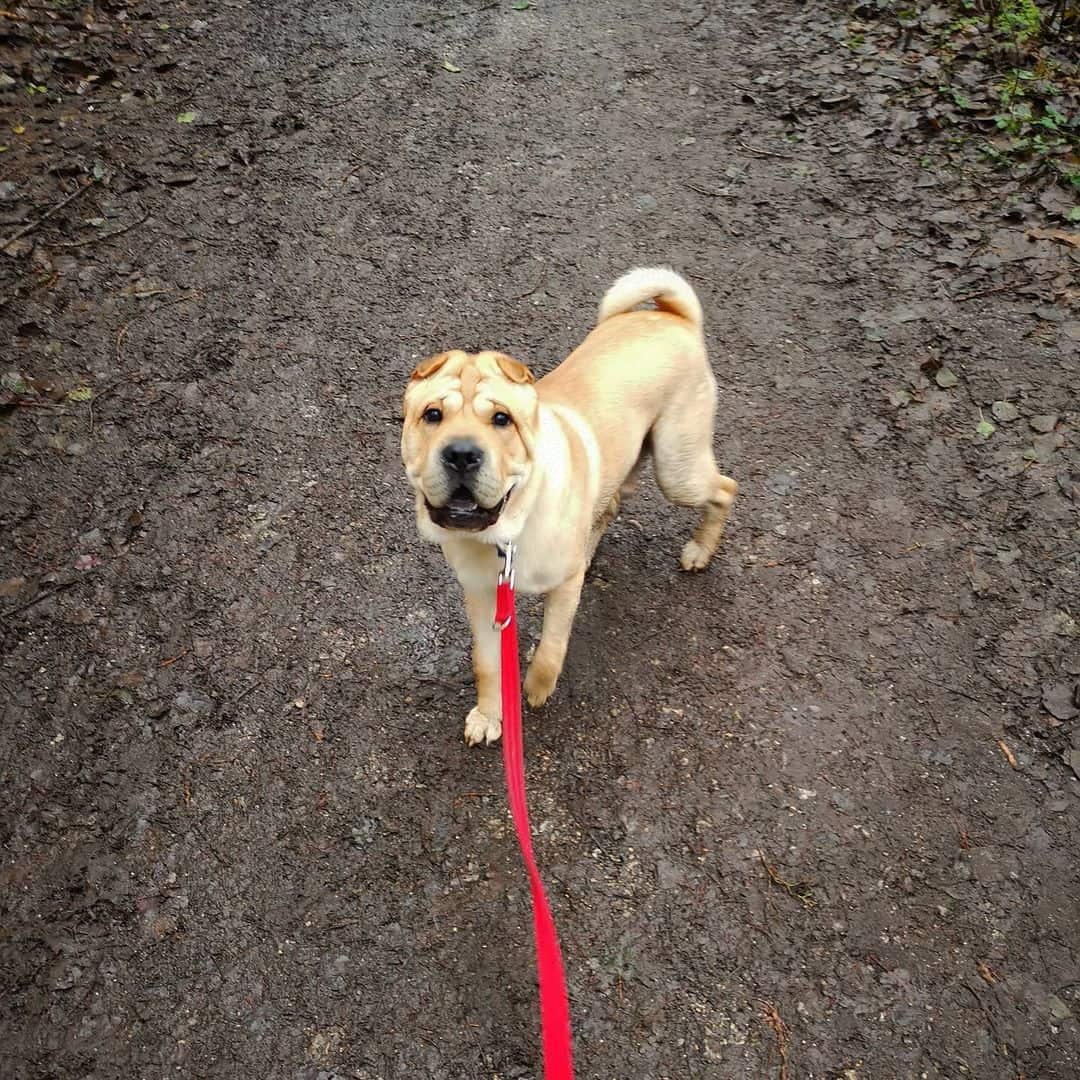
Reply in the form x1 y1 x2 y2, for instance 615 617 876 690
402 269 739 745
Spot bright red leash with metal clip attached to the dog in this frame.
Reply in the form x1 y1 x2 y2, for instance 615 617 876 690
495 544 573 1080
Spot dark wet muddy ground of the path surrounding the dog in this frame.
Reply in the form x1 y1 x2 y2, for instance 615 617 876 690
0 0 1080 1080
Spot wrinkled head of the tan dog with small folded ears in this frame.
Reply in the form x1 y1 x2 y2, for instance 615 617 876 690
402 351 537 532
